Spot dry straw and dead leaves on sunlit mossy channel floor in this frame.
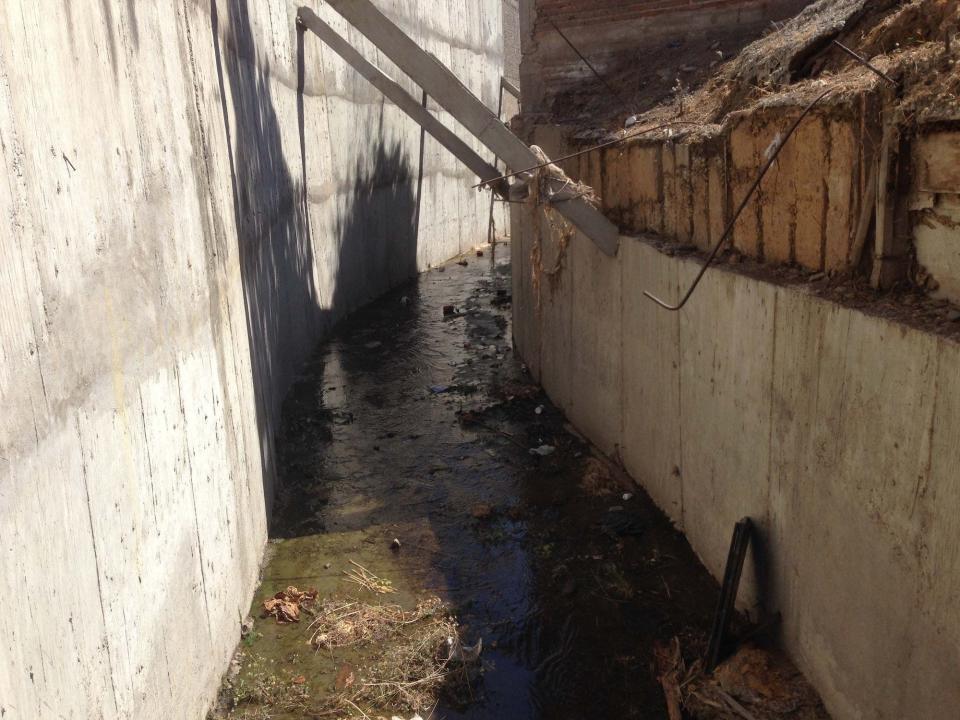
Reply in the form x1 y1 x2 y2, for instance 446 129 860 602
211 563 482 720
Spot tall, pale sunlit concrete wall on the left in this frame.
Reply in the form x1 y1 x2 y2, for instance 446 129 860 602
0 0 503 720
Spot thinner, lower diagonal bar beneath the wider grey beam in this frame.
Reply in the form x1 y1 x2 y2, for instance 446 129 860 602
297 8 507 197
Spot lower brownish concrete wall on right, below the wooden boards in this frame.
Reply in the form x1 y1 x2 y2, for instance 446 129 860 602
513 206 960 720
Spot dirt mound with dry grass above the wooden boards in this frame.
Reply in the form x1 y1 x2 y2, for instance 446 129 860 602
560 0 960 134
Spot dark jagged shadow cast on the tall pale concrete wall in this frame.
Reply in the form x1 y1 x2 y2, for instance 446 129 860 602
210 0 423 508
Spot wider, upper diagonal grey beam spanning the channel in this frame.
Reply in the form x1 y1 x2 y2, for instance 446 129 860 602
312 0 620 255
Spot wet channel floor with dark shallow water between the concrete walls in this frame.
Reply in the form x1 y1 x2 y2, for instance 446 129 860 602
212 246 822 720
